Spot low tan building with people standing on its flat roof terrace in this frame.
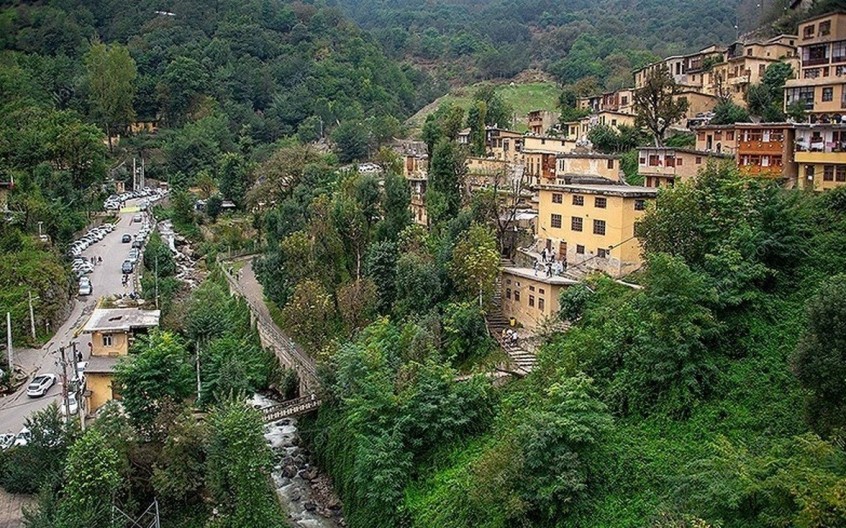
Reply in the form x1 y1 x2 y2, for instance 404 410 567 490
500 268 577 328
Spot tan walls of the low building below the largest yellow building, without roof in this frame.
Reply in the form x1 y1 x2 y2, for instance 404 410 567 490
502 271 565 328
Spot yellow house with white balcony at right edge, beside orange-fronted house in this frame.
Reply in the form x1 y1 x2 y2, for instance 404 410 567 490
794 123 846 191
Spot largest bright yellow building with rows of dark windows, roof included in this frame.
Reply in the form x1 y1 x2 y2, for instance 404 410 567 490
537 182 658 277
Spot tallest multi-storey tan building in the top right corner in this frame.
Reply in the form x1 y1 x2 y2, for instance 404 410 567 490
784 12 846 123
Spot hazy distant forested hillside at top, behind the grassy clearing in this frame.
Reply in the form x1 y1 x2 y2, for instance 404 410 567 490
336 0 784 89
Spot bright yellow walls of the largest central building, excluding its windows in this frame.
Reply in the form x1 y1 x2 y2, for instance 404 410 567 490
537 188 651 276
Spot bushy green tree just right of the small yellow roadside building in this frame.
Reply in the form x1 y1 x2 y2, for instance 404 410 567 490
115 331 194 436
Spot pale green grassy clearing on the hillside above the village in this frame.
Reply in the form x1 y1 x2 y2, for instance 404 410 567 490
406 82 560 136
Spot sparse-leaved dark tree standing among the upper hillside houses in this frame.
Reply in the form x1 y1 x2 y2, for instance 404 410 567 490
634 68 689 146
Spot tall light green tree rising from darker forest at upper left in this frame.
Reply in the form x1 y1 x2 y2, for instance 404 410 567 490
84 40 138 150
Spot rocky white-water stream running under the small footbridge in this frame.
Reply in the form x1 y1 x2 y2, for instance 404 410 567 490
250 394 346 528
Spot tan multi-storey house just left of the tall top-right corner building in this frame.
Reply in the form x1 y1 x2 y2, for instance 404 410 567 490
704 35 799 106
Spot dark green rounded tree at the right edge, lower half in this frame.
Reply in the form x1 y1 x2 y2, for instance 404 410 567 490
793 275 846 435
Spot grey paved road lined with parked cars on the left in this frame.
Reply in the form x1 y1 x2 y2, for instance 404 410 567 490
0 200 149 433
